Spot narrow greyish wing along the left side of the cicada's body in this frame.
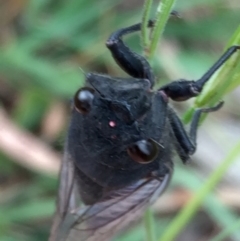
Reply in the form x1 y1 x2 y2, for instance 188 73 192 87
49 152 80 241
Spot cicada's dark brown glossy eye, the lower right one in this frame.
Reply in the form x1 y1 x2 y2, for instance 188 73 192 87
127 139 159 164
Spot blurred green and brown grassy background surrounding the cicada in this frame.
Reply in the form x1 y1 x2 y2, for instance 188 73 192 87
0 0 240 241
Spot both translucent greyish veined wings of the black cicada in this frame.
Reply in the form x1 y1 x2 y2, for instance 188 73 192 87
50 152 171 241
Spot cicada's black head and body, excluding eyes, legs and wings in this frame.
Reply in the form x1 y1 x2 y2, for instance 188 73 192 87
67 74 173 204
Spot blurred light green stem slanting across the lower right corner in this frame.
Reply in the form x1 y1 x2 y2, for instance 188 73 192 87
159 142 240 241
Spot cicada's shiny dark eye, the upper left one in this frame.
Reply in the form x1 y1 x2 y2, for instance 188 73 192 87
74 87 94 114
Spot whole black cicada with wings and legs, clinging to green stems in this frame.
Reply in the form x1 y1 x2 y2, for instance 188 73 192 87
50 21 239 241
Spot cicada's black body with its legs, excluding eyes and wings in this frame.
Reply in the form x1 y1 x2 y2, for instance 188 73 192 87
66 21 237 204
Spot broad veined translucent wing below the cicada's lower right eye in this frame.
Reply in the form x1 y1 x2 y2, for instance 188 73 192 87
62 174 171 241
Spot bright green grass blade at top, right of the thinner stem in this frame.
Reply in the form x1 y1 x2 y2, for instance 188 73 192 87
149 0 175 59
